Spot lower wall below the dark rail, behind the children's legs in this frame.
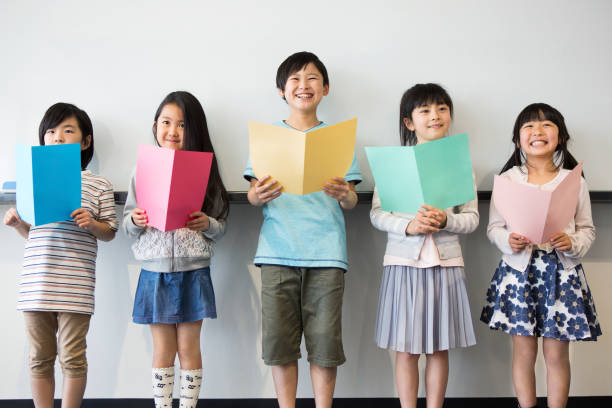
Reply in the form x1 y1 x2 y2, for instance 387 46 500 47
0 203 612 399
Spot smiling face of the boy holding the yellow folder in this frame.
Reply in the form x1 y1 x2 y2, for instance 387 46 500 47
278 63 329 113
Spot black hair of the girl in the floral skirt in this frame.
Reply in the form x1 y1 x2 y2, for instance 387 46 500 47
499 103 584 176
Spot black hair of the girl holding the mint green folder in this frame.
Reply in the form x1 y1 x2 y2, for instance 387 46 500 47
399 83 453 146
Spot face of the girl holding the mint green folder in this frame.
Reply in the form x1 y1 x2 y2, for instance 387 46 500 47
403 103 451 144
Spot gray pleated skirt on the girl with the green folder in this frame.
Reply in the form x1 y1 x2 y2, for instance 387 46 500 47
374 265 476 354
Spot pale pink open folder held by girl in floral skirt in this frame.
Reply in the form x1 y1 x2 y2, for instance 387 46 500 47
493 163 582 244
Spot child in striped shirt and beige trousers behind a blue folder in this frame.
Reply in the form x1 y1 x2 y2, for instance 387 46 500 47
4 103 117 408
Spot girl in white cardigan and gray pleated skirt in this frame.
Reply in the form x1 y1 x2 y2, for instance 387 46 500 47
370 84 479 408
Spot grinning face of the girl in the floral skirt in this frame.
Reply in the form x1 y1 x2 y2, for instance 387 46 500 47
519 120 559 161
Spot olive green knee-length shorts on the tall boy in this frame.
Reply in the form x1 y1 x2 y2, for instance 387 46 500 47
261 265 346 367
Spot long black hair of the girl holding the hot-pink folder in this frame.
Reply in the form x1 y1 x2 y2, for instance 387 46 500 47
153 91 229 219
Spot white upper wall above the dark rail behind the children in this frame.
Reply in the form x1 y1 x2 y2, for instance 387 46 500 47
0 0 612 190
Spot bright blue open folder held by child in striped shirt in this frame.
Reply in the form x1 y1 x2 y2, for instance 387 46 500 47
15 143 81 226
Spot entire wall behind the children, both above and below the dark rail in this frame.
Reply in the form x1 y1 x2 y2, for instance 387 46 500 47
0 0 612 398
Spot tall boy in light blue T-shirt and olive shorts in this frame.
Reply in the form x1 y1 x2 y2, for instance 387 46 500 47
244 52 361 408
